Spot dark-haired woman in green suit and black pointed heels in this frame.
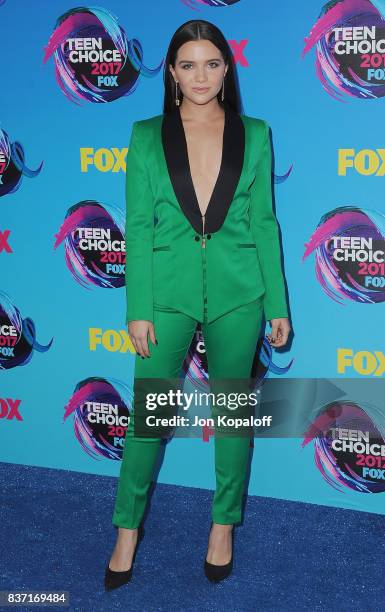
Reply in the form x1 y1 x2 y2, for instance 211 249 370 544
105 20 290 589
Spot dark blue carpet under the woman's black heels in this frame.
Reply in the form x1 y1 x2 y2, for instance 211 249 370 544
0 463 385 612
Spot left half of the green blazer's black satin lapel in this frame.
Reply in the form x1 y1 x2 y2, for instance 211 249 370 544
162 109 202 233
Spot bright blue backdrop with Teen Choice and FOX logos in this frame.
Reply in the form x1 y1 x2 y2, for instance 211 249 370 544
0 0 385 513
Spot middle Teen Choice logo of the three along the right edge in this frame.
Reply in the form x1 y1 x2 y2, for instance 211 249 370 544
302 206 385 304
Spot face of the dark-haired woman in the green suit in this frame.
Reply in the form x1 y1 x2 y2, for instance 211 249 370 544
170 40 227 104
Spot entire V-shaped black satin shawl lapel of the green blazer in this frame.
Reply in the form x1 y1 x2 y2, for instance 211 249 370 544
162 107 245 234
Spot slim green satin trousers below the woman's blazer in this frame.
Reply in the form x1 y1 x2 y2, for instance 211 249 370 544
112 298 263 529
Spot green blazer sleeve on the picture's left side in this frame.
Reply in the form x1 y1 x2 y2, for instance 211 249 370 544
125 121 154 323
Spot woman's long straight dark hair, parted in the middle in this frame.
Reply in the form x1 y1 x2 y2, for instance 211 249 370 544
163 19 241 113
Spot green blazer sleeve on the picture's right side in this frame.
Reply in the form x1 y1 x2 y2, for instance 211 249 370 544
250 121 288 321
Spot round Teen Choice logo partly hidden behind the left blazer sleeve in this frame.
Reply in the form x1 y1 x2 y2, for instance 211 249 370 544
54 200 126 289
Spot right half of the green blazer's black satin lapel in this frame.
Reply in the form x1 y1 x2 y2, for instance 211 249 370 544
205 108 245 233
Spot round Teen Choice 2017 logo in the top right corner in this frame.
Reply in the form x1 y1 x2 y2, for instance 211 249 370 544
302 0 385 101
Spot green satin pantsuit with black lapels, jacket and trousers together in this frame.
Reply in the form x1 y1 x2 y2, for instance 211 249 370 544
112 108 287 529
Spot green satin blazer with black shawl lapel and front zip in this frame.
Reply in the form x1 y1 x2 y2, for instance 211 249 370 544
125 107 288 323
